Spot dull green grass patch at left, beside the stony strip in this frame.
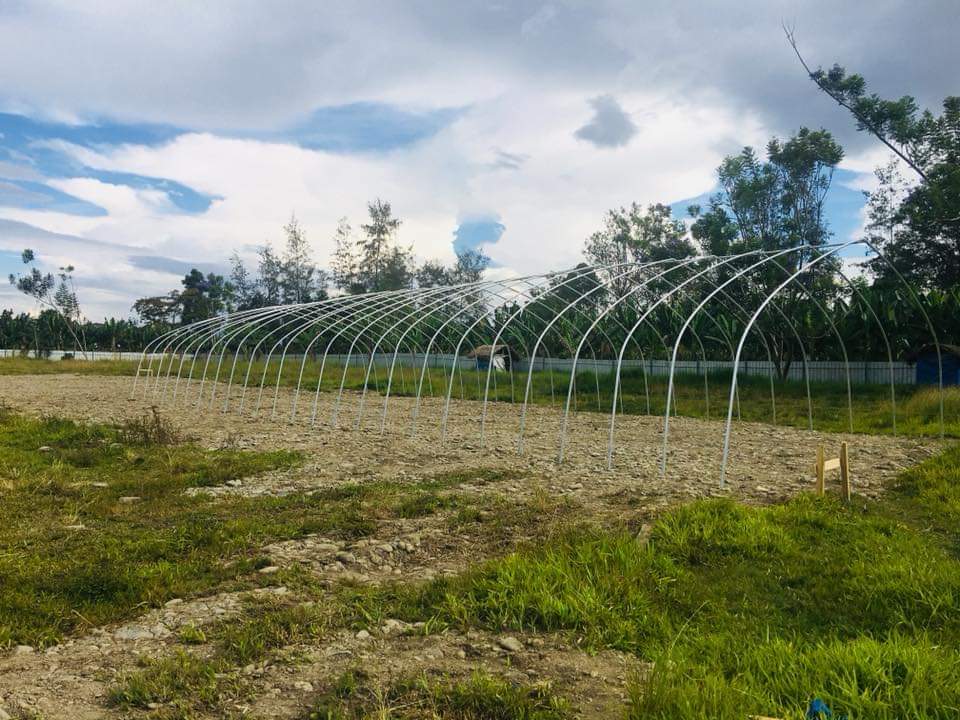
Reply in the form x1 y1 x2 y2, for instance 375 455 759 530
0 404 360 647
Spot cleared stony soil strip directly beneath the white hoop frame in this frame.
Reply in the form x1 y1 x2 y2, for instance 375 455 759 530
0 375 938 501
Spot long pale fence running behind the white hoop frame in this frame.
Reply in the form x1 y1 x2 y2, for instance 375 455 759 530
0 349 917 385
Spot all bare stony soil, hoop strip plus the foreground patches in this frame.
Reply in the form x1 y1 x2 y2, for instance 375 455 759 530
0 375 939 718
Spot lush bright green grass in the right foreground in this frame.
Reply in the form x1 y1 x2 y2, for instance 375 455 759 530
343 446 960 720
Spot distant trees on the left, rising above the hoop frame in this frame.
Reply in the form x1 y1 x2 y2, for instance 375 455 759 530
0 198 490 355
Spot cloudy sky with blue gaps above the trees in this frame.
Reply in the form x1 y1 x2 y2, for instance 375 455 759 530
0 0 960 319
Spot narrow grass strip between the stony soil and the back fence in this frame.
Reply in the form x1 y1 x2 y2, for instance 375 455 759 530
0 358 960 437
